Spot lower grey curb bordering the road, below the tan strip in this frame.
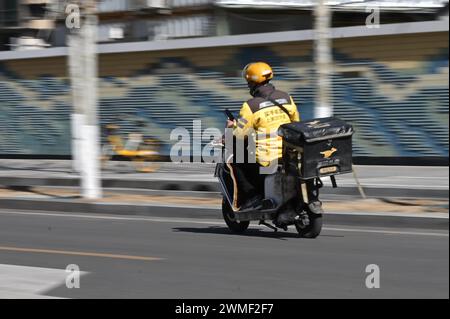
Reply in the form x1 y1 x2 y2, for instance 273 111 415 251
0 198 449 230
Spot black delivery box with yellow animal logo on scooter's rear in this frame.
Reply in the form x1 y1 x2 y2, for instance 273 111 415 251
278 117 354 179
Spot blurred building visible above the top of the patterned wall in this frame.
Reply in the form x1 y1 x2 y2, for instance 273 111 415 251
0 0 448 50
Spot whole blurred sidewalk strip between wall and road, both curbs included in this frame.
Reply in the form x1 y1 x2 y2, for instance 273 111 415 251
0 160 449 230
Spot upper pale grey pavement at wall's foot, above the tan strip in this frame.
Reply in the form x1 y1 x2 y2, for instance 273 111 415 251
0 159 449 198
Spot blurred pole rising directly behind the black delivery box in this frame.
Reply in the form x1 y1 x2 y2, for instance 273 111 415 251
314 0 333 118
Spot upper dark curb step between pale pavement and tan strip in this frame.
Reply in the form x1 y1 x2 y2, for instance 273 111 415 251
0 177 449 198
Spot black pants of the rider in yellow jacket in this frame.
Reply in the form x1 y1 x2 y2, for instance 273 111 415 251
232 163 264 202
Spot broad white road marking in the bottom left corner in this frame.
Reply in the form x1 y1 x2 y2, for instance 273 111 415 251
0 264 86 299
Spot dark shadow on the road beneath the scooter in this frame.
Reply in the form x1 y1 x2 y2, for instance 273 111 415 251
172 226 344 240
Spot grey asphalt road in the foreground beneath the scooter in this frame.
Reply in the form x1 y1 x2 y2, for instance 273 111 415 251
0 210 449 298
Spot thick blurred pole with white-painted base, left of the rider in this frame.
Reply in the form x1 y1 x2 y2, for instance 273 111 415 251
69 0 102 199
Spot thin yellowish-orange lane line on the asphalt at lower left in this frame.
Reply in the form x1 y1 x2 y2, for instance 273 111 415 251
0 246 162 261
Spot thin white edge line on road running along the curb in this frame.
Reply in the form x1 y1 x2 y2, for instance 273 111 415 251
0 210 449 237
